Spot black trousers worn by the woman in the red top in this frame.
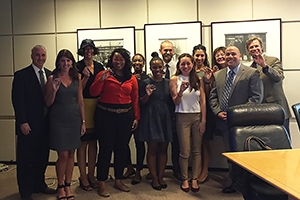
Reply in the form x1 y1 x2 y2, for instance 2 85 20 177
94 107 134 181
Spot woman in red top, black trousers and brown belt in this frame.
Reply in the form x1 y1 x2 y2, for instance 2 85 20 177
90 48 140 197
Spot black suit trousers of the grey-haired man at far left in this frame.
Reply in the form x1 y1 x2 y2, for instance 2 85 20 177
17 122 49 198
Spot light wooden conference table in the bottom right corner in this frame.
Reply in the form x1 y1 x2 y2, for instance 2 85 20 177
223 149 300 199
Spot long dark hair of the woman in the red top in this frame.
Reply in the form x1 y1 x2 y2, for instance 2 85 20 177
106 48 132 80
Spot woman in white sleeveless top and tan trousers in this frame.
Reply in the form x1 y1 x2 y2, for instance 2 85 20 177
170 53 206 192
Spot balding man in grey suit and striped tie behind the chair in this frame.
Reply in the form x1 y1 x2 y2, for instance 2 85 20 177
209 46 263 193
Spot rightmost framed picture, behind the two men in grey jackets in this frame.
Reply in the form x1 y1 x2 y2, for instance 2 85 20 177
211 19 281 66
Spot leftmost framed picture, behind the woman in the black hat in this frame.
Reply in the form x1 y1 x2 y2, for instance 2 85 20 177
77 26 135 66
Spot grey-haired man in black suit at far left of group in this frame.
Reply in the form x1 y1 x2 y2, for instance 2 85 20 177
12 45 56 200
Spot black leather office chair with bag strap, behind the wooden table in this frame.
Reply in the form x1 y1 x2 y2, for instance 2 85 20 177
227 104 292 200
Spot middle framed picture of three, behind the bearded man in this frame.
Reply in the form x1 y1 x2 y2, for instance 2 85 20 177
144 21 202 74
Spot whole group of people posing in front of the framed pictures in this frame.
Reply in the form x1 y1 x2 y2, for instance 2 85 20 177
12 37 290 200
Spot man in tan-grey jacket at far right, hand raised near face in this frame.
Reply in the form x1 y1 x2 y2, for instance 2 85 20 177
246 37 291 133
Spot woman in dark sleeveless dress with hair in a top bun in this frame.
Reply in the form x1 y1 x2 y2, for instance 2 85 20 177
137 52 174 190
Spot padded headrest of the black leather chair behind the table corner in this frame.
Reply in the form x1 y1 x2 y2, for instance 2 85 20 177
227 103 285 128
